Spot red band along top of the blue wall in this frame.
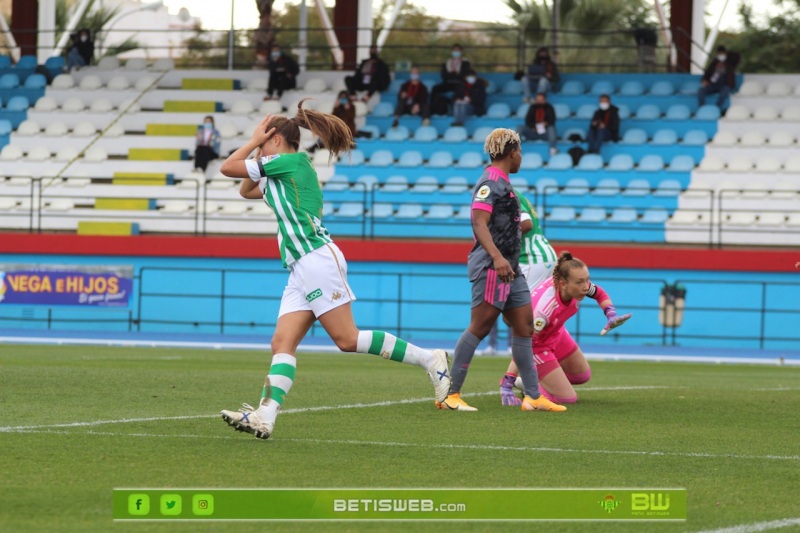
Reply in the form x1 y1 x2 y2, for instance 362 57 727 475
0 233 800 274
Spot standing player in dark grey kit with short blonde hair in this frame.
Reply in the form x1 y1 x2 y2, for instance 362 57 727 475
437 128 566 411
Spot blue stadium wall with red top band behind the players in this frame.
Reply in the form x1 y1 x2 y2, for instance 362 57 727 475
0 234 800 356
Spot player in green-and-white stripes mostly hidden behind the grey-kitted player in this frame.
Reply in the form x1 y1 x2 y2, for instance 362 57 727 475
514 189 558 292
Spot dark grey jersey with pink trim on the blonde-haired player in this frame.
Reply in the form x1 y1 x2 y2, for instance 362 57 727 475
467 167 522 281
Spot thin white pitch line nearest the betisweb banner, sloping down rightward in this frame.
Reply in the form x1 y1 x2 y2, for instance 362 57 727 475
12 429 800 462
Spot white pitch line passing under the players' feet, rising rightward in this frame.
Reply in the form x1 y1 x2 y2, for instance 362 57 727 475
0 385 670 433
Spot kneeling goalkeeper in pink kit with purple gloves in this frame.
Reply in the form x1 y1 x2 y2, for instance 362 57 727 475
500 252 632 405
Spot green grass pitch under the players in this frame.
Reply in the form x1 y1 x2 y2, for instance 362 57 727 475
0 345 800 533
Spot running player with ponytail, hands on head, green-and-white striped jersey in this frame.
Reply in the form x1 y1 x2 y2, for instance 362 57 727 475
220 100 450 439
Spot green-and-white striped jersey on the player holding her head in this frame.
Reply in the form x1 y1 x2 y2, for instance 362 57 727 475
253 152 333 267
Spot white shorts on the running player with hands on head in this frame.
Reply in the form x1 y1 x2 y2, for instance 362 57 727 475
278 243 356 317
